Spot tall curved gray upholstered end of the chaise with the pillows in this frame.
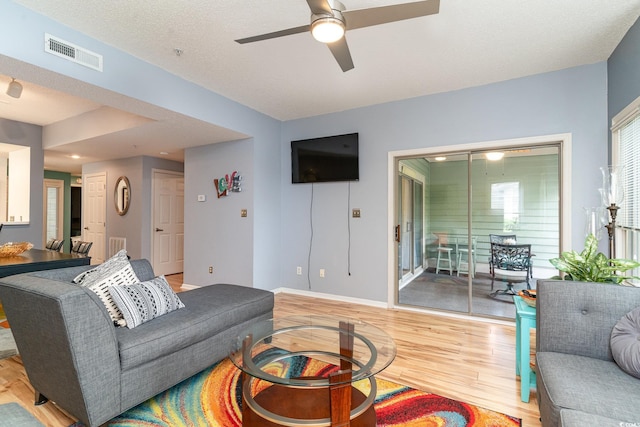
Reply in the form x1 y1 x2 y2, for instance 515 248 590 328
0 274 121 425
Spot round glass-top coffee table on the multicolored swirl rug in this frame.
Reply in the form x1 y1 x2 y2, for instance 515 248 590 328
229 316 396 427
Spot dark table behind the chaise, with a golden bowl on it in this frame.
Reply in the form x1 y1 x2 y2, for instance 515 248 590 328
0 249 91 277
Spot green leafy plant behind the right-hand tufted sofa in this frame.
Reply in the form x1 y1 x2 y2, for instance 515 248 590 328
549 234 640 284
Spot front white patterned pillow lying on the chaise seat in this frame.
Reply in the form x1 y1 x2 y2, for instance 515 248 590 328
109 276 184 329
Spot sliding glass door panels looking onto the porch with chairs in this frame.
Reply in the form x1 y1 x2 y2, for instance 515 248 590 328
396 144 561 318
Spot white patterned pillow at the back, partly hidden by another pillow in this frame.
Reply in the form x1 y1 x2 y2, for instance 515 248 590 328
73 249 140 326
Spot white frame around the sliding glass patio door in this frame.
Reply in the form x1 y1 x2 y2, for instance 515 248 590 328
387 133 572 313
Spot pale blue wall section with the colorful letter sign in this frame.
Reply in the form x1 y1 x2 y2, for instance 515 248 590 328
185 139 254 286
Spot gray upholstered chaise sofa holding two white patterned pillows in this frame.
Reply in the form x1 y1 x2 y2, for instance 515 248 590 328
0 260 274 427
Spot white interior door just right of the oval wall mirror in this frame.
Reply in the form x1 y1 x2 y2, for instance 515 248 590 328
152 171 184 275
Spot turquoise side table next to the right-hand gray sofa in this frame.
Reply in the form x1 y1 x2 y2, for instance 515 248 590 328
513 296 536 402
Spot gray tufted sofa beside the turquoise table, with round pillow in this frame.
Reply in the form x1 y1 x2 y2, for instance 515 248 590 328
536 280 640 427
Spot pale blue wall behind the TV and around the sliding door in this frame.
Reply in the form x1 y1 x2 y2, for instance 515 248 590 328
281 62 608 301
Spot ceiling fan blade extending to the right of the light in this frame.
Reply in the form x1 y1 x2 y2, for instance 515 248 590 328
344 0 440 30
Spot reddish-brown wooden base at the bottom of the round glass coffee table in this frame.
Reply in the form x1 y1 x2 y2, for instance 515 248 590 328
242 380 376 427
